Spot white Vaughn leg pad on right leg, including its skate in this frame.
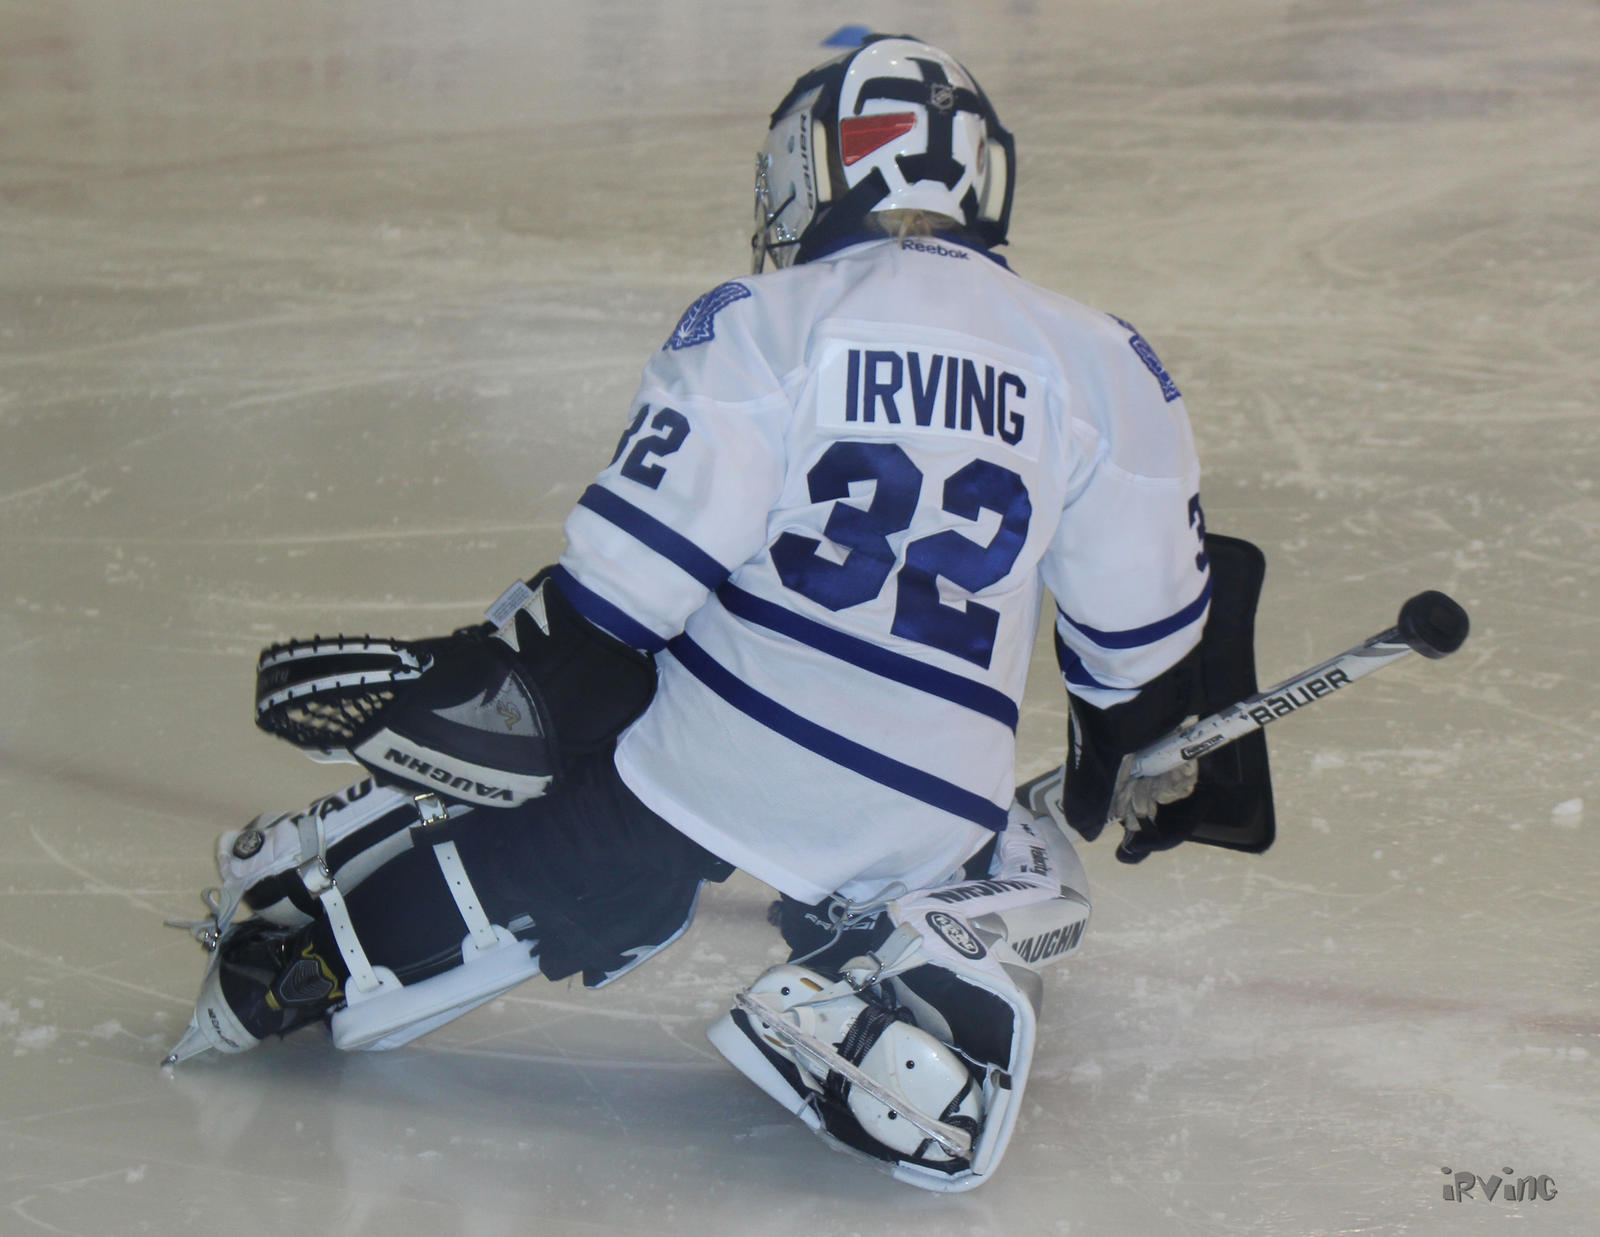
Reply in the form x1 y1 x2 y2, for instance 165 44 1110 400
707 805 1090 1191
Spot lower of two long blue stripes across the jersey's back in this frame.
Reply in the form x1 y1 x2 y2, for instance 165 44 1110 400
667 635 1006 832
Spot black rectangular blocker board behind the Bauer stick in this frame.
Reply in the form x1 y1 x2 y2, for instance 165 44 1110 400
1158 533 1277 853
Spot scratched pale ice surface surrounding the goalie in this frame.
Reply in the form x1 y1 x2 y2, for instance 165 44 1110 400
0 0 1600 1237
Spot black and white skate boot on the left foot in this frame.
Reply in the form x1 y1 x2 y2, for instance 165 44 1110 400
165 919 344 1066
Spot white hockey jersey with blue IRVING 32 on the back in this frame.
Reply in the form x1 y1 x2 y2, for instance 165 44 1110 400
558 237 1210 903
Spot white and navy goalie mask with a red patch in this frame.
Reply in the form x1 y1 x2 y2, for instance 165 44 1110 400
750 35 1016 272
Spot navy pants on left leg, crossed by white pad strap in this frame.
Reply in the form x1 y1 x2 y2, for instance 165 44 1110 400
315 749 733 987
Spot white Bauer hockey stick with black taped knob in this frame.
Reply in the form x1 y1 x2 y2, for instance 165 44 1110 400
1016 589 1470 815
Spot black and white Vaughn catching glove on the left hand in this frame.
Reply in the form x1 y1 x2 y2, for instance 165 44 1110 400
256 570 656 808
